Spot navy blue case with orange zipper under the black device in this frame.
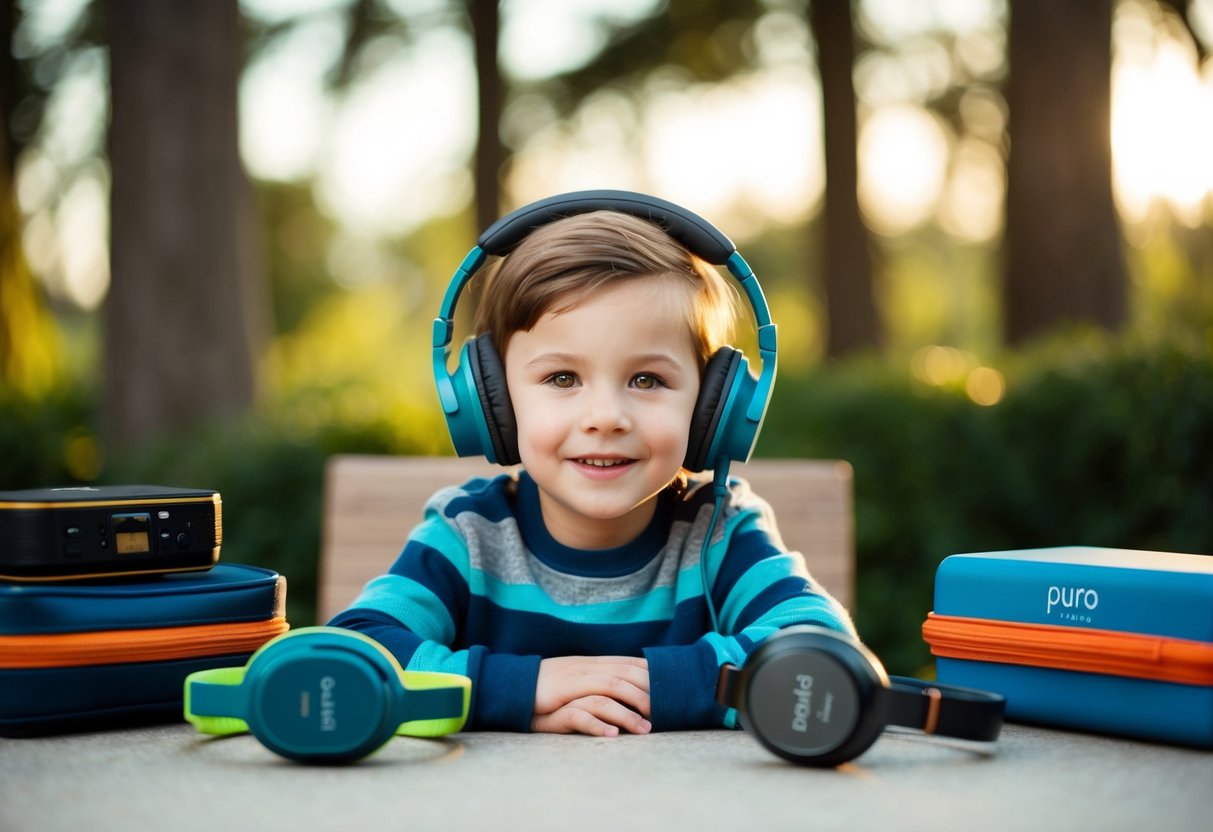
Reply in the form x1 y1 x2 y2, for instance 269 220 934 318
0 564 287 736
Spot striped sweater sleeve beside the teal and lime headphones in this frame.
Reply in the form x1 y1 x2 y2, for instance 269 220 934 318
329 502 540 731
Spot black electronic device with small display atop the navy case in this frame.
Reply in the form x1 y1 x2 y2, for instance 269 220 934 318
0 485 223 581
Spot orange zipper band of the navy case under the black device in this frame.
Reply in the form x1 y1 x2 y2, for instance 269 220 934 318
0 616 290 668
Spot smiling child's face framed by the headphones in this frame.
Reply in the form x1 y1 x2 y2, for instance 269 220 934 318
505 279 699 549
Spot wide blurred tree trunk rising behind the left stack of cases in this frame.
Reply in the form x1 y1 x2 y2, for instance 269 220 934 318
103 0 268 444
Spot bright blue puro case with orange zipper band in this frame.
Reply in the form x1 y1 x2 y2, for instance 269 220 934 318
923 546 1213 747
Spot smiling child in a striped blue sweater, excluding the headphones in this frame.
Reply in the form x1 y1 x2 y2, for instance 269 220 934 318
331 204 854 736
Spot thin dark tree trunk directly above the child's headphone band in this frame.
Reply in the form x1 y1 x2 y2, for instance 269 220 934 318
468 0 505 233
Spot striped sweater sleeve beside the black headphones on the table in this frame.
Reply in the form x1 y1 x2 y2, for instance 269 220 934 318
644 494 855 730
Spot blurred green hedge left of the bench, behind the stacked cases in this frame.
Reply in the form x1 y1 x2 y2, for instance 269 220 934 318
0 378 433 626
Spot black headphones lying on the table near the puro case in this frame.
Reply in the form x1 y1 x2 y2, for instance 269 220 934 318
716 625 1007 767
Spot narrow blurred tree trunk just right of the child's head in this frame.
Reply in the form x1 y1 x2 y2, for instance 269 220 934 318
810 0 879 358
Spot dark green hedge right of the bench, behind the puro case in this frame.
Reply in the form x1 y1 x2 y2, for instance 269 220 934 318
759 329 1213 673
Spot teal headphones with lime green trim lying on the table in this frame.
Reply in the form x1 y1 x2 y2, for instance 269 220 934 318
184 627 472 763
